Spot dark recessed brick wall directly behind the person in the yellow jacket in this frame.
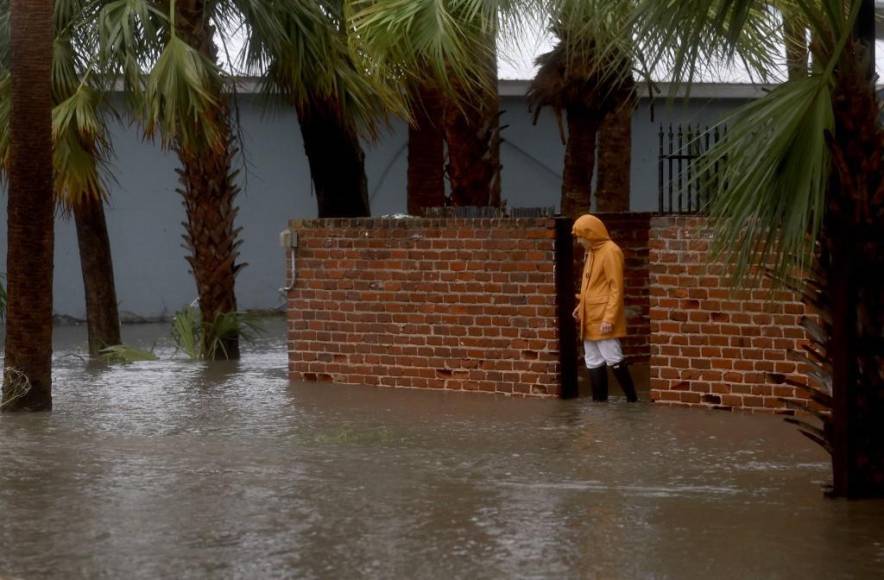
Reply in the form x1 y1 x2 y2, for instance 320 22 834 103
592 213 651 362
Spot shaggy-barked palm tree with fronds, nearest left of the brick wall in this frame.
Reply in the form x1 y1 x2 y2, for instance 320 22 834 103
100 0 242 359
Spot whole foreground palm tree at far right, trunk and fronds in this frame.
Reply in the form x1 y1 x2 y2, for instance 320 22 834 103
638 0 884 498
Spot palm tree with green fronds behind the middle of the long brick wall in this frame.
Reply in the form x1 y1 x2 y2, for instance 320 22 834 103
348 0 541 206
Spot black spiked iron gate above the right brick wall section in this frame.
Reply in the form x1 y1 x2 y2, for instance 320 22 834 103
657 124 727 214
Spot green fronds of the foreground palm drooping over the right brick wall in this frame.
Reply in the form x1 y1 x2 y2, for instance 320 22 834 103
639 0 859 288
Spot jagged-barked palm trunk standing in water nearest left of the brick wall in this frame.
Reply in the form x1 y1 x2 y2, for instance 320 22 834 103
176 0 242 359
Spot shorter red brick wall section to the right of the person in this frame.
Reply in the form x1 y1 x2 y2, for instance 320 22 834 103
649 217 806 412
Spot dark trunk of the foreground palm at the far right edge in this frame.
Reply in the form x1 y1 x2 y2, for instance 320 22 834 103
821 37 884 498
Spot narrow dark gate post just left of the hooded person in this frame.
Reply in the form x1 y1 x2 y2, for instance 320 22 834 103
555 217 578 399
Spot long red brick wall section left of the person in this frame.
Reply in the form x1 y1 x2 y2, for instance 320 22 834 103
287 218 559 397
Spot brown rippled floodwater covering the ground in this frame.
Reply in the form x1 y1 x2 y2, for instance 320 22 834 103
0 322 884 579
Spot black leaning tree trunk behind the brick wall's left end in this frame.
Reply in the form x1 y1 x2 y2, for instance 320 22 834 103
298 97 371 218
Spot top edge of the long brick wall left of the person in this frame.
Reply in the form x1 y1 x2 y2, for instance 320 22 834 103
289 217 554 230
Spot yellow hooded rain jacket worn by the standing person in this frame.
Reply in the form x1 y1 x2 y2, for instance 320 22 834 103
571 214 626 340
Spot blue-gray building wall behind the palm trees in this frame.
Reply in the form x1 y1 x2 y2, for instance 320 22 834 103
0 96 739 319
